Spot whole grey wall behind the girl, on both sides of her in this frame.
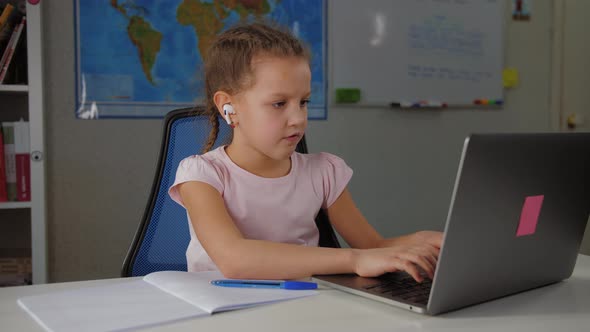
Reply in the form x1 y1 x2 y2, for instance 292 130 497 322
44 1 587 281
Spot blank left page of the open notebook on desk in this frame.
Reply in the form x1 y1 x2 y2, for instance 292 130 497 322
18 280 209 332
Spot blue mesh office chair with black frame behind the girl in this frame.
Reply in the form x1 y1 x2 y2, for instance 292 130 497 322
121 108 340 277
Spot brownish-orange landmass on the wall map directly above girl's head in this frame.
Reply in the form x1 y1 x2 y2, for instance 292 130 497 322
176 0 270 57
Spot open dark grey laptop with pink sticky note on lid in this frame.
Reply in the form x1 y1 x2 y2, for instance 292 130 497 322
314 133 590 315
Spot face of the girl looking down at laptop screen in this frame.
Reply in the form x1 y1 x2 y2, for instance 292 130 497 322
232 56 311 160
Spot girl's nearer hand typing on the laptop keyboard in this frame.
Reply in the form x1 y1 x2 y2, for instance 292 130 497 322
353 244 440 282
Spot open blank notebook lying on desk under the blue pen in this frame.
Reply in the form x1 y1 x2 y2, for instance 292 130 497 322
18 271 317 332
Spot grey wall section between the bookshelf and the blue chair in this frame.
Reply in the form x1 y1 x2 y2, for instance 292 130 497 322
43 1 162 282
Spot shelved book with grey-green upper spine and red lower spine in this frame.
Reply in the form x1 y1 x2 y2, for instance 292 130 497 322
14 120 31 202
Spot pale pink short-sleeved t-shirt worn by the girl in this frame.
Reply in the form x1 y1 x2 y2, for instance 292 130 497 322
168 147 352 272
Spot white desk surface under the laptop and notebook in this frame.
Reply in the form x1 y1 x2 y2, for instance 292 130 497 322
0 255 590 332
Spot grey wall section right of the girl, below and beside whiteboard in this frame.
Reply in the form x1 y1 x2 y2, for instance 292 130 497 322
308 1 552 236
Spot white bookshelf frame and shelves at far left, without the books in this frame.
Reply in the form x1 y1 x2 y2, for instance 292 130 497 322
0 1 47 284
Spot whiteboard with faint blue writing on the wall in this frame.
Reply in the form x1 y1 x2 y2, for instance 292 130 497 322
329 0 504 105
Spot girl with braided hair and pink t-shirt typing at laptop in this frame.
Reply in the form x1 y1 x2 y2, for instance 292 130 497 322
169 23 442 282
